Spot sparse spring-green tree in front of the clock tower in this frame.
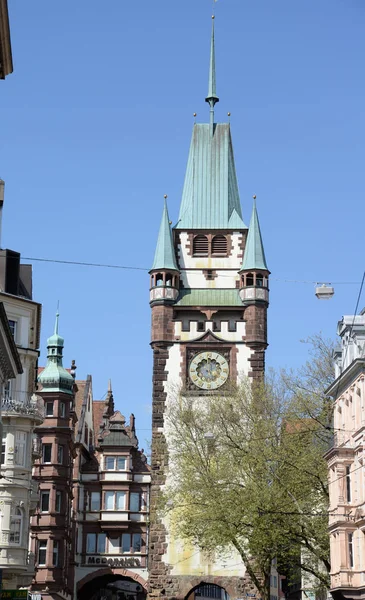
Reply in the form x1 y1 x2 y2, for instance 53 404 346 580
162 336 333 599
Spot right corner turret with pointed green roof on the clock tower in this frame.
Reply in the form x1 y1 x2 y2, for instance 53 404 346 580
239 196 270 306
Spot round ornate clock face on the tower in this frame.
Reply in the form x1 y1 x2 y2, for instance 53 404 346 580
189 352 229 390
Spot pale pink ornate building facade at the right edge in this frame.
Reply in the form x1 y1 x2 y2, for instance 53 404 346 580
326 310 365 600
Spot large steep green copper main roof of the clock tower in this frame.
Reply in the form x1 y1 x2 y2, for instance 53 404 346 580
175 123 247 230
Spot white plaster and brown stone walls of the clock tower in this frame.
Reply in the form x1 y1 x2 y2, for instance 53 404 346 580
149 230 267 598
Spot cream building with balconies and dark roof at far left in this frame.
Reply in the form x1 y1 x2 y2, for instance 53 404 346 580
0 180 43 589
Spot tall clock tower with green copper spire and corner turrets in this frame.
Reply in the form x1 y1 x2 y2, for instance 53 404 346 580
149 17 269 600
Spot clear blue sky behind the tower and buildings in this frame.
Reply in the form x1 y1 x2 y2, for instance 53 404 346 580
0 0 365 446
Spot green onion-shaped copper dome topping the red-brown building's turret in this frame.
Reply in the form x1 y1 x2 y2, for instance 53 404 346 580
38 312 74 395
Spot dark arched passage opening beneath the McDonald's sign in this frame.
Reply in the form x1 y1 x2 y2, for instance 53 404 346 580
77 574 146 600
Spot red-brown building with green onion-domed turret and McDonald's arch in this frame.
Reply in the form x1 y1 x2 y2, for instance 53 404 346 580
31 322 150 600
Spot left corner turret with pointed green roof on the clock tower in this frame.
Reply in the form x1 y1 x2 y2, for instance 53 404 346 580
150 196 180 305
